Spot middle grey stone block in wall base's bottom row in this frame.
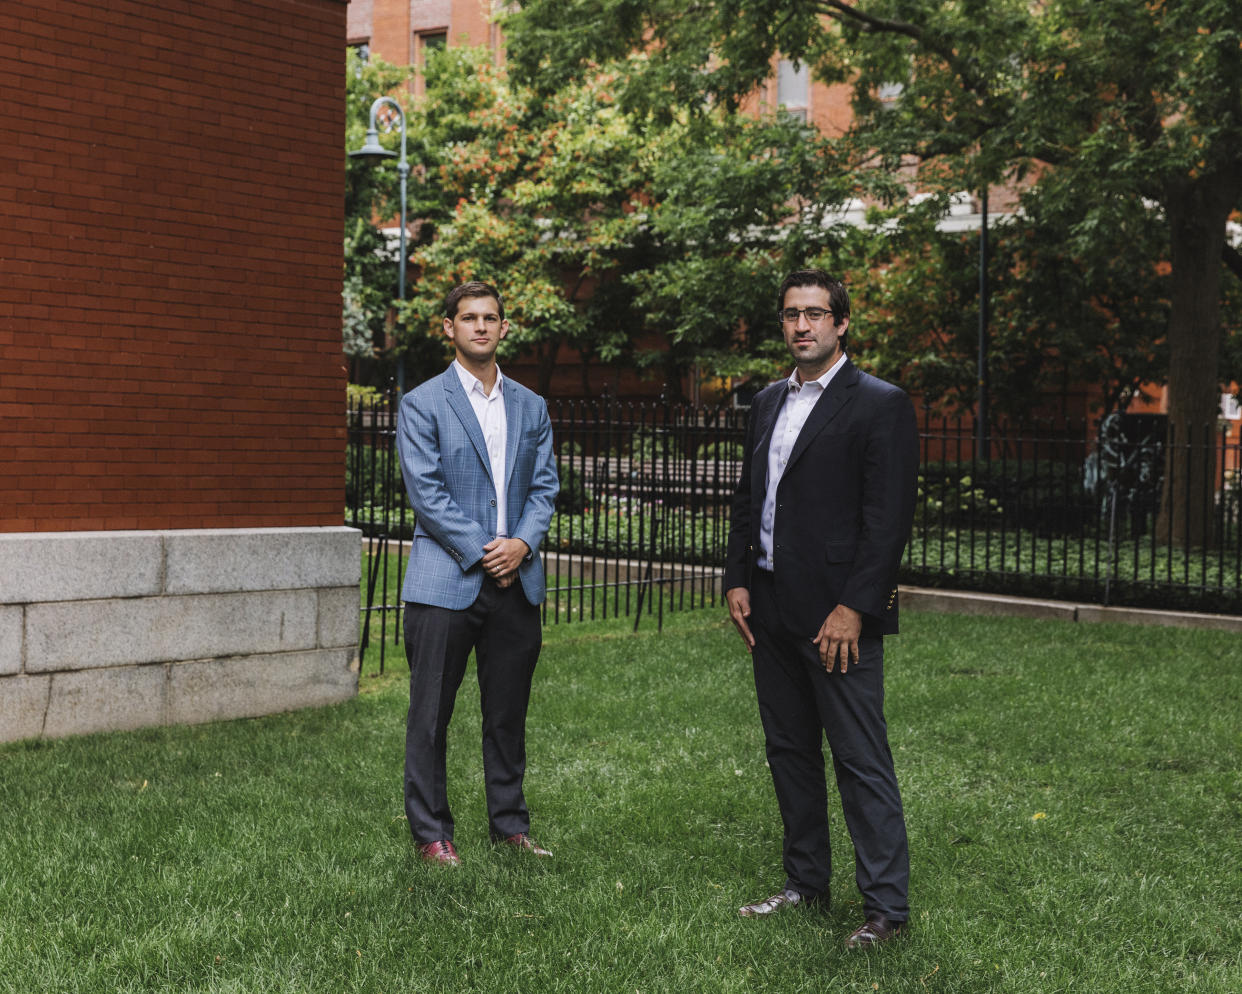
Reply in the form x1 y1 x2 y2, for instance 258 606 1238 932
43 666 168 738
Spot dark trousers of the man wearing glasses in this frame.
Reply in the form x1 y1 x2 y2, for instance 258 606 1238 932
750 569 910 922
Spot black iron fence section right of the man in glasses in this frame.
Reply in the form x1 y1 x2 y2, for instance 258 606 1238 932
902 415 1242 614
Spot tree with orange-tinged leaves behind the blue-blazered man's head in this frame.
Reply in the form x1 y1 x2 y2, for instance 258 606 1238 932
404 48 641 393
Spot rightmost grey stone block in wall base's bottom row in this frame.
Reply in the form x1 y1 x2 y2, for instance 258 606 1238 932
168 649 358 724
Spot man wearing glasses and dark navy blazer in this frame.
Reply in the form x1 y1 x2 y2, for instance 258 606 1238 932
724 270 918 948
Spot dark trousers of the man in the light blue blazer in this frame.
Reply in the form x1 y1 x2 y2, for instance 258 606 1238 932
405 579 543 842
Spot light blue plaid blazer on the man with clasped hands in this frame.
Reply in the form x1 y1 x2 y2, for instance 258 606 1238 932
396 365 560 610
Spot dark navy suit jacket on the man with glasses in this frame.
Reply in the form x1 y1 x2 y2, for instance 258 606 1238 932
724 358 919 639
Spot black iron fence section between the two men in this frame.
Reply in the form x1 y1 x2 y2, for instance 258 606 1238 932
544 400 745 627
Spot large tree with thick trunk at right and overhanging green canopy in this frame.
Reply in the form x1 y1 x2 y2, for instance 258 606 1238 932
507 0 1242 544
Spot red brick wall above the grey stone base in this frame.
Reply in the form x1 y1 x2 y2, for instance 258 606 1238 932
0 0 345 532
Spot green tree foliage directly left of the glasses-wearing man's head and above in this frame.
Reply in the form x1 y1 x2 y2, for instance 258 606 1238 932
628 113 853 379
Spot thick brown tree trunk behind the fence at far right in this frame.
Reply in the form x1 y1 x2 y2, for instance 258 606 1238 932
1156 180 1233 547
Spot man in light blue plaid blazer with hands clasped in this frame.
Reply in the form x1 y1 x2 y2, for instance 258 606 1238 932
397 277 559 865
